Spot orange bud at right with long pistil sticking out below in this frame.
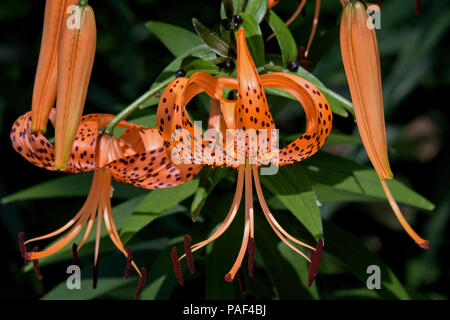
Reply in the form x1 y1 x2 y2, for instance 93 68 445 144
340 1 429 249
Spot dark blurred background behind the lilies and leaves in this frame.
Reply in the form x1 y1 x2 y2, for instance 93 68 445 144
0 0 450 299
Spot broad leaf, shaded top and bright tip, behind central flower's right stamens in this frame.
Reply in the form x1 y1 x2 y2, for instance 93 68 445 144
261 165 323 238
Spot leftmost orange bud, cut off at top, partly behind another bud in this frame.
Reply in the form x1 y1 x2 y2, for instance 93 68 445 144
31 0 78 133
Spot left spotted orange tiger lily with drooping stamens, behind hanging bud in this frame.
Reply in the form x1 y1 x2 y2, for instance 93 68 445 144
11 109 196 298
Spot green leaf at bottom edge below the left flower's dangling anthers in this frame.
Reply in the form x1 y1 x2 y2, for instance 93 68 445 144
41 278 137 300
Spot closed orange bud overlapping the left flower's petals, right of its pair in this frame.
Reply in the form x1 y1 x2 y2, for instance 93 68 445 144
54 1 97 170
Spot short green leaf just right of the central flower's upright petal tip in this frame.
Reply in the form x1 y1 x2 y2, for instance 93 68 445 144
236 12 264 67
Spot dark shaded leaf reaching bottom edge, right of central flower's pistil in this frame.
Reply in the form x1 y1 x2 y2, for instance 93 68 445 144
255 214 317 299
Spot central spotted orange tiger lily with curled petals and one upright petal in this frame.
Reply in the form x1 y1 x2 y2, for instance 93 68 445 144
157 29 332 285
